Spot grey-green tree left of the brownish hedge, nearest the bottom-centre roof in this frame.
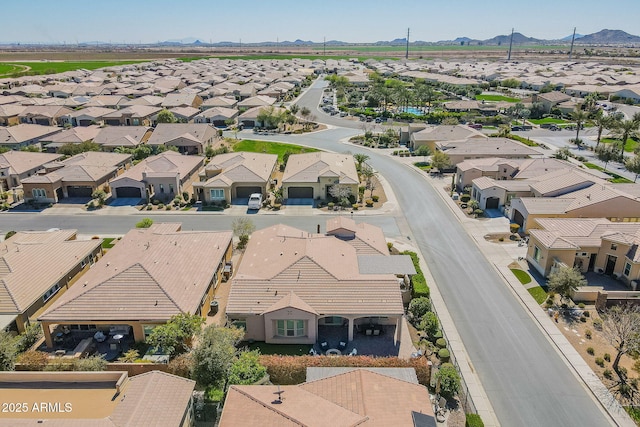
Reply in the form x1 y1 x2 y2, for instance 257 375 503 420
191 325 244 386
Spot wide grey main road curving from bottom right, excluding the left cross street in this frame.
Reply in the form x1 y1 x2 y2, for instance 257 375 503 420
288 81 611 426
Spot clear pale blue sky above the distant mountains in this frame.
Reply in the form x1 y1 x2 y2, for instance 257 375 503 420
5 0 640 44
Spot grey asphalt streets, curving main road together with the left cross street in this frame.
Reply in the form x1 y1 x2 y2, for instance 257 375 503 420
0 78 611 427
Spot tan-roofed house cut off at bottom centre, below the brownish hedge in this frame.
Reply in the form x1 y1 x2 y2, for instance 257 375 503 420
220 368 436 427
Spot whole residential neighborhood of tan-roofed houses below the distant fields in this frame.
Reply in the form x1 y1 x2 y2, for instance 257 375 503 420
0 46 640 427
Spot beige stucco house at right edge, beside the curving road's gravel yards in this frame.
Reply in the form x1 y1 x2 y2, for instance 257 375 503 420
527 218 640 290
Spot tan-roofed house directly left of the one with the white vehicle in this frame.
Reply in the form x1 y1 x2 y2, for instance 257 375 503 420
109 151 204 201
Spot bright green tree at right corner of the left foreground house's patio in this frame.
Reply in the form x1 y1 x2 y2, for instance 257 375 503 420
147 313 204 356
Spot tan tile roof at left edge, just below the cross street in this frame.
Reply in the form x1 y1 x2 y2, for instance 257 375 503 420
0 230 101 313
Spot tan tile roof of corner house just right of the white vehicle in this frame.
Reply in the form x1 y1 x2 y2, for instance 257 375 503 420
282 152 360 184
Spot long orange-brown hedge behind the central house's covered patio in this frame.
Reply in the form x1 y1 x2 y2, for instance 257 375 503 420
260 354 431 386
